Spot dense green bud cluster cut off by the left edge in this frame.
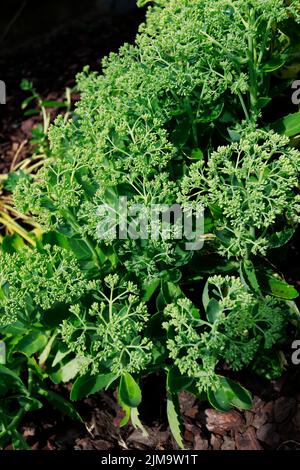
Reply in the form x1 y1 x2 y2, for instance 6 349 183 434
0 245 85 325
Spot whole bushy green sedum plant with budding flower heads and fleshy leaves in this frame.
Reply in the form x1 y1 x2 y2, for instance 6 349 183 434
0 0 300 447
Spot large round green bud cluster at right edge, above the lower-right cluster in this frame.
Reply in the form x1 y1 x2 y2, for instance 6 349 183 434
181 130 300 259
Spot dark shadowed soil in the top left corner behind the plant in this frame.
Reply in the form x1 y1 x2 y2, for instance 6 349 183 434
0 0 144 171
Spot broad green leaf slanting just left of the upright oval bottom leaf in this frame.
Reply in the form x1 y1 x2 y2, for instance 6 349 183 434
70 374 118 401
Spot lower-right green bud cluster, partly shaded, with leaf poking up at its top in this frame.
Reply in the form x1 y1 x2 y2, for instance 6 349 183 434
164 276 291 393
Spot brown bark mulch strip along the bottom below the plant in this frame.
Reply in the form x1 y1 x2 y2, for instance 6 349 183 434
13 369 300 450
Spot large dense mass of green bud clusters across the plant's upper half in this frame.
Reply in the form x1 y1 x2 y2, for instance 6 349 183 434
16 0 298 231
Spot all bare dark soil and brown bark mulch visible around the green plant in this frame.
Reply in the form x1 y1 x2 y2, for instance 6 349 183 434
0 3 300 450
